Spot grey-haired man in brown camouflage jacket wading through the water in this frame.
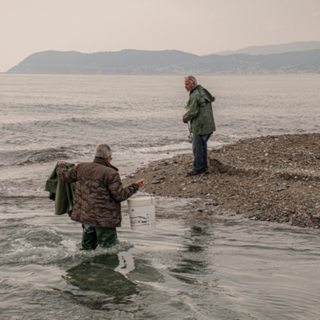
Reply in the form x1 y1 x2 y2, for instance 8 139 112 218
56 144 144 250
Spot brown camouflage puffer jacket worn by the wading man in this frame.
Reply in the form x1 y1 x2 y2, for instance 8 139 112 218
56 158 139 228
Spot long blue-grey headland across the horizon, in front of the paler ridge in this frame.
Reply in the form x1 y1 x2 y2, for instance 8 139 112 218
7 49 320 74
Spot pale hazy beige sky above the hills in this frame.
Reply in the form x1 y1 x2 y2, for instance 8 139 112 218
0 0 320 72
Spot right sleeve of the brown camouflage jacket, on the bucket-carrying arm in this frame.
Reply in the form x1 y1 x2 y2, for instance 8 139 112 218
106 172 139 202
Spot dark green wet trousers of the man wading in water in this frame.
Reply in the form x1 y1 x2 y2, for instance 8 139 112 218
81 224 117 250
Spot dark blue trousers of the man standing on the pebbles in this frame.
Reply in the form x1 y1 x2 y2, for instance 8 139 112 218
192 132 212 173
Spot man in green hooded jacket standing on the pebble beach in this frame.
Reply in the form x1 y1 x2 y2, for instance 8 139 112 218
183 76 216 176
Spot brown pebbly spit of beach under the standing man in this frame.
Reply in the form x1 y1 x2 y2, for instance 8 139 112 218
123 133 320 229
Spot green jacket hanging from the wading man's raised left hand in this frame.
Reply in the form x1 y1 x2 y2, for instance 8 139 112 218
45 162 76 216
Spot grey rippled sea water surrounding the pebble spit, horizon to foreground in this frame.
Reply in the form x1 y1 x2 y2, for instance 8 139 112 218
0 74 320 320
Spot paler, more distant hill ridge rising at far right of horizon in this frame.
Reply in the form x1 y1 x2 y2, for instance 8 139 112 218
214 41 320 56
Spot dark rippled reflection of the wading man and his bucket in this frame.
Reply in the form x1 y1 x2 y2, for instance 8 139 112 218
63 251 163 310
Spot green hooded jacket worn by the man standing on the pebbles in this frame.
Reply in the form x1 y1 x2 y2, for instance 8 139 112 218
183 84 216 135
